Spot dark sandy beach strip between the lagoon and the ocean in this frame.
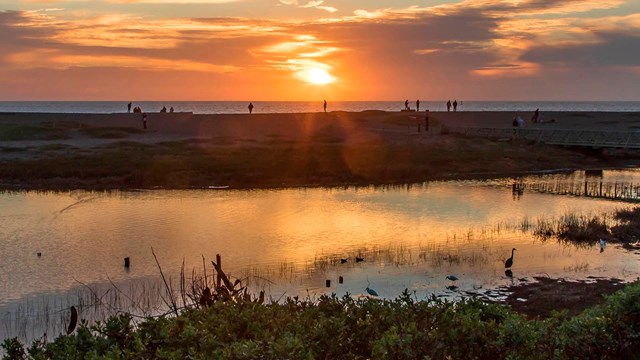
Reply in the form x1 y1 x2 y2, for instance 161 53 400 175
0 111 640 189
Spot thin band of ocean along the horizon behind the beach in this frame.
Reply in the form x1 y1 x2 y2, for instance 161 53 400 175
0 99 640 114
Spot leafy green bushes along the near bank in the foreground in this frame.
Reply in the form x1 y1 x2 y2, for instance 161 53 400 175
2 284 640 359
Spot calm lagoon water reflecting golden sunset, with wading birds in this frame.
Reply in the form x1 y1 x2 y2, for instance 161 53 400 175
0 170 640 338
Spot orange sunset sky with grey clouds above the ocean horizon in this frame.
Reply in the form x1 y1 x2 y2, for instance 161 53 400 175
0 0 640 101
